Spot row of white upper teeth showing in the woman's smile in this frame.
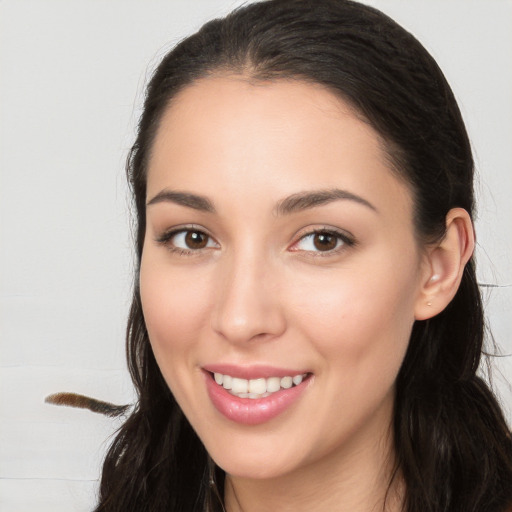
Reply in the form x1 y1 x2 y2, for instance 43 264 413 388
213 373 306 399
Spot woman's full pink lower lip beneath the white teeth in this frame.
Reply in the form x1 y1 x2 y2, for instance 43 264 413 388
205 372 311 425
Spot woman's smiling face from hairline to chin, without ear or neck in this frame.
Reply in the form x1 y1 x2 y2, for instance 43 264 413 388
140 76 424 478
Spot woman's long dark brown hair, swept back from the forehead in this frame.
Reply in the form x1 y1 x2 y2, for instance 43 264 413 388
96 0 512 512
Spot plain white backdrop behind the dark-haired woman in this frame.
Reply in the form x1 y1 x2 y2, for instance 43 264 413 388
0 0 512 512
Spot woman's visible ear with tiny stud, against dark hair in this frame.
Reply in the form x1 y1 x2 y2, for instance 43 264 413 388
414 208 475 320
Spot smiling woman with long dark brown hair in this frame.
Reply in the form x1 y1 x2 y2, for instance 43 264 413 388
97 0 512 512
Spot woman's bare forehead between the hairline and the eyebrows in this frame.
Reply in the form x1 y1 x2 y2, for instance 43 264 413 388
148 76 411 226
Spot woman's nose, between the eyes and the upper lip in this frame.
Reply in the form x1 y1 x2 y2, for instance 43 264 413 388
211 253 286 344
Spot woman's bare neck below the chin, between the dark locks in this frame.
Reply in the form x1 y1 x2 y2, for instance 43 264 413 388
224 412 403 512
